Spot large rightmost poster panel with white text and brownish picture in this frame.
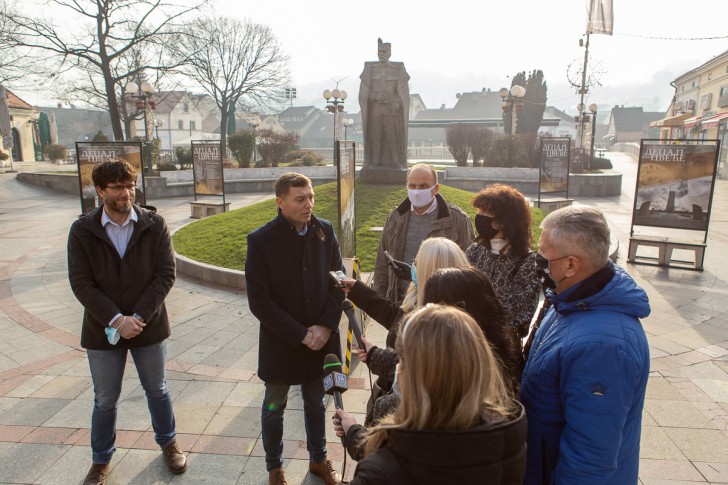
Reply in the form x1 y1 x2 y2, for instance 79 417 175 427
632 140 720 231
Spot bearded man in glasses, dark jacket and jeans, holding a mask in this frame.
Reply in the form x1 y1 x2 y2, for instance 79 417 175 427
68 160 187 485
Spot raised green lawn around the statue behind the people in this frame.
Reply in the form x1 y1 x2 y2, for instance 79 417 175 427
174 183 543 272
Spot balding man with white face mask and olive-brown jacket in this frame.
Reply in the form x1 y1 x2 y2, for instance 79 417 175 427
373 163 475 304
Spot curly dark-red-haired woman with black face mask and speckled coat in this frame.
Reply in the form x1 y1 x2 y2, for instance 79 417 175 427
465 184 541 366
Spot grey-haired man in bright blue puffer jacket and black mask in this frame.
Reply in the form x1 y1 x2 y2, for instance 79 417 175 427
520 206 650 485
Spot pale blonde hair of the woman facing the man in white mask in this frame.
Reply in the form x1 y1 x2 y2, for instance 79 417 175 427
402 237 470 312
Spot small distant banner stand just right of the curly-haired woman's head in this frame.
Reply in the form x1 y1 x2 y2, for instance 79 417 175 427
536 136 574 213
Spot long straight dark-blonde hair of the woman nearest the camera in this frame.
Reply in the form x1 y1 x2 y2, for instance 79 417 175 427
364 303 517 455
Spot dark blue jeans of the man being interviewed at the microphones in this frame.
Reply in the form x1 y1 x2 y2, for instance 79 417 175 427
261 379 326 471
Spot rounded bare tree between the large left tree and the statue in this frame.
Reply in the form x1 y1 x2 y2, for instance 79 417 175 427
173 16 290 157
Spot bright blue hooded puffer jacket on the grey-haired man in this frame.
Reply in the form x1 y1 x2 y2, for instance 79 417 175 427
521 263 650 485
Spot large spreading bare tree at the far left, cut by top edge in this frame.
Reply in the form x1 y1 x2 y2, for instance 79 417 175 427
3 0 203 140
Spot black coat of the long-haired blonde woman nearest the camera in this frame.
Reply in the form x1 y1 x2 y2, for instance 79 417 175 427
350 405 527 485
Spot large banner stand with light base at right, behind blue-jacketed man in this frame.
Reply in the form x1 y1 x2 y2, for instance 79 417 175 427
627 139 720 271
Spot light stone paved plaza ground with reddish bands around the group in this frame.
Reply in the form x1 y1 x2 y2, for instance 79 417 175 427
0 154 728 485
